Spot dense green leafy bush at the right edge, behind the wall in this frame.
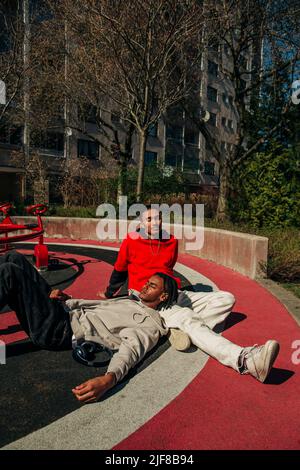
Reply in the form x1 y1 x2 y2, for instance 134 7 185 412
229 142 300 228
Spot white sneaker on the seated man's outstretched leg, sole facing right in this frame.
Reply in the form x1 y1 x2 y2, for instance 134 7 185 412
242 339 279 382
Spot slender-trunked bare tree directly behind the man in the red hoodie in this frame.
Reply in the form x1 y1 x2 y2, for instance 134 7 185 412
45 0 206 198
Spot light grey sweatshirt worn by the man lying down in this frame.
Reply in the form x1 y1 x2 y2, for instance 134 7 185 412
66 297 168 382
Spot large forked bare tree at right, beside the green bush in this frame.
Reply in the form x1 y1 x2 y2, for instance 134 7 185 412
185 0 300 220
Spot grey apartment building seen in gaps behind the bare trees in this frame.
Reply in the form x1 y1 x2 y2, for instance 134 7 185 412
0 0 258 201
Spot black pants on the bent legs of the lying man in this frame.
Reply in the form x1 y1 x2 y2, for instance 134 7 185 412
0 251 72 350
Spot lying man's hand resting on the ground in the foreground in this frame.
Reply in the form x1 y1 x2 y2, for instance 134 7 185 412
72 372 116 403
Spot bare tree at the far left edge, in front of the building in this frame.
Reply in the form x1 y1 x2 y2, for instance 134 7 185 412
0 0 59 200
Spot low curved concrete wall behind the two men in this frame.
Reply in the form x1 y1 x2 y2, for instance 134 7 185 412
14 217 268 279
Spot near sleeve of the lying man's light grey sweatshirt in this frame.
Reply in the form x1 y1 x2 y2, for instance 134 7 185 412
107 328 160 382
